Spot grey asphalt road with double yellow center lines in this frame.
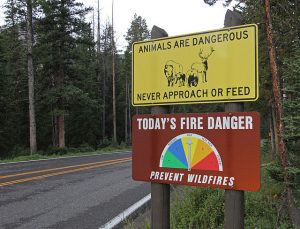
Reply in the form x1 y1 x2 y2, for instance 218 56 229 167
0 153 150 229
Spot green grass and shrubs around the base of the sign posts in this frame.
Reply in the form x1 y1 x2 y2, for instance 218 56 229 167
125 144 299 229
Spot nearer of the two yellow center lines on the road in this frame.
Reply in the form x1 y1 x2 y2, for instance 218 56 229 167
0 158 132 187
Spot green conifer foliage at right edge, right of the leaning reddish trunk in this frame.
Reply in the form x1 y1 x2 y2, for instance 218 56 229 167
283 40 300 222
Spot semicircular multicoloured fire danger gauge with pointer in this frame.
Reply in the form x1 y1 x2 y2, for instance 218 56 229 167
159 133 223 171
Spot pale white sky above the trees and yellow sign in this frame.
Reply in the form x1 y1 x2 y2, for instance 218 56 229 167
0 0 231 50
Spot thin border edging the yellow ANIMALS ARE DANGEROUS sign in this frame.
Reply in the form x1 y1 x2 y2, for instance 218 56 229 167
131 24 259 106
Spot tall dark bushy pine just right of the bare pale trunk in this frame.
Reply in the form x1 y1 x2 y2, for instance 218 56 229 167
37 0 90 148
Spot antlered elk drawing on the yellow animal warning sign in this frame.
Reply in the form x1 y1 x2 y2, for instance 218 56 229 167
187 47 215 87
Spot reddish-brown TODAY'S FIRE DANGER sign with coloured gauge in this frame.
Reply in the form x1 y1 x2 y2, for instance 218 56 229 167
132 112 260 191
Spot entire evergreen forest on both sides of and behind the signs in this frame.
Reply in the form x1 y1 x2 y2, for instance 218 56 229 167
0 0 300 225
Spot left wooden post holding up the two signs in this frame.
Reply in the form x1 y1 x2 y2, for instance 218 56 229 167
151 26 170 229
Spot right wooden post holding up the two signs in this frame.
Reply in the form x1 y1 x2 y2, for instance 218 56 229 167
224 10 245 229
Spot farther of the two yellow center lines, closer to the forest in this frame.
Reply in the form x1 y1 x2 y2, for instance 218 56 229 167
0 157 131 179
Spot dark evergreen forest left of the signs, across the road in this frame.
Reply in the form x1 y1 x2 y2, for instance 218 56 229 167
0 0 149 158
